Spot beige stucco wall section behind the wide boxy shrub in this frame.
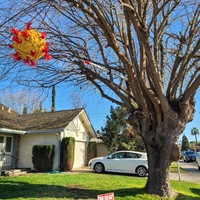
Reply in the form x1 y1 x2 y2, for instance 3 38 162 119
18 133 59 169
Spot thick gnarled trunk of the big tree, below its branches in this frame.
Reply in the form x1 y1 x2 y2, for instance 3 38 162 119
129 112 183 198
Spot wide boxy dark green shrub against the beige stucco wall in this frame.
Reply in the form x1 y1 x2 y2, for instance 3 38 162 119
32 145 55 172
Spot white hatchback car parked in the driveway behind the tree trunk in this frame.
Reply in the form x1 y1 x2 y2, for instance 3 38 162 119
88 151 148 177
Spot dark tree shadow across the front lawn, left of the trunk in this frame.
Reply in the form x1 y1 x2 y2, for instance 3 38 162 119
0 181 145 199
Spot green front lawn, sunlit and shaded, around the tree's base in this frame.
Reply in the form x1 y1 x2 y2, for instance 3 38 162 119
0 173 200 200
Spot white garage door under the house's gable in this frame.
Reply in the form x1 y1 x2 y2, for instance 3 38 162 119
73 141 87 168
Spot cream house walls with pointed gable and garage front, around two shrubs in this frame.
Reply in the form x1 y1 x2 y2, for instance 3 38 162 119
18 116 94 170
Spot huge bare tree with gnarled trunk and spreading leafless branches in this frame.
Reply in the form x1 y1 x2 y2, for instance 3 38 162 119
0 0 200 197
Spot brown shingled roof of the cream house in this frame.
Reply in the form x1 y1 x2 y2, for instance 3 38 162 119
0 104 83 131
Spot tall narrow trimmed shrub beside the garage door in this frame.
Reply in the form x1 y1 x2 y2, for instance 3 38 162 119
60 137 75 171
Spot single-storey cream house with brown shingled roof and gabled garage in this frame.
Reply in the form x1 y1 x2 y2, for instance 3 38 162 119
0 104 96 170
